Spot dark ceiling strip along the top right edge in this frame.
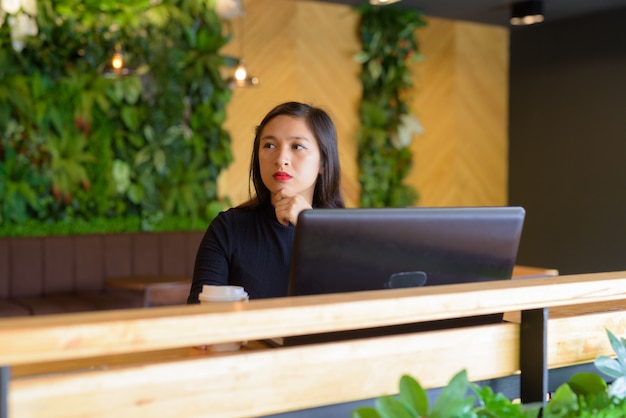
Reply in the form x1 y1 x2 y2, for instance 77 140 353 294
308 0 626 26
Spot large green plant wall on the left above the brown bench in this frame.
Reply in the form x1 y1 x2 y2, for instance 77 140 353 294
0 0 233 235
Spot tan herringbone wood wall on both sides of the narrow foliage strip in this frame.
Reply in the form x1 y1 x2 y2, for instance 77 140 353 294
214 0 509 206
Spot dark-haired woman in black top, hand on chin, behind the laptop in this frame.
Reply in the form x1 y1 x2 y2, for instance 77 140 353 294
187 102 344 303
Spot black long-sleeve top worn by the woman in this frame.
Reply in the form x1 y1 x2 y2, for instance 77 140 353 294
187 201 295 303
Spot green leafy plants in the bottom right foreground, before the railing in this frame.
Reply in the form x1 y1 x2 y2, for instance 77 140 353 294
352 330 626 418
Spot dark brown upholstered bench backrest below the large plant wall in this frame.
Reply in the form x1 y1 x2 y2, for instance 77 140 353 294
0 231 204 298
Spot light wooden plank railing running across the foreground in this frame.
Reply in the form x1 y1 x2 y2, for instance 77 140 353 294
0 272 626 418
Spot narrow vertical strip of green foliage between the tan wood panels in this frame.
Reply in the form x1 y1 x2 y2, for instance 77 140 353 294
356 4 425 207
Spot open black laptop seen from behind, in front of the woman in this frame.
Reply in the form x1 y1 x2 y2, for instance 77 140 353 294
268 206 525 345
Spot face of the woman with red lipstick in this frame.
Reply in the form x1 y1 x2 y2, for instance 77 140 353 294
259 115 321 204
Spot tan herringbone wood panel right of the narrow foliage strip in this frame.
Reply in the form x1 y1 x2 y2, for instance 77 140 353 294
407 19 508 206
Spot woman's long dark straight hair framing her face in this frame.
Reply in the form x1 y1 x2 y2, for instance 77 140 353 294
242 102 345 208
